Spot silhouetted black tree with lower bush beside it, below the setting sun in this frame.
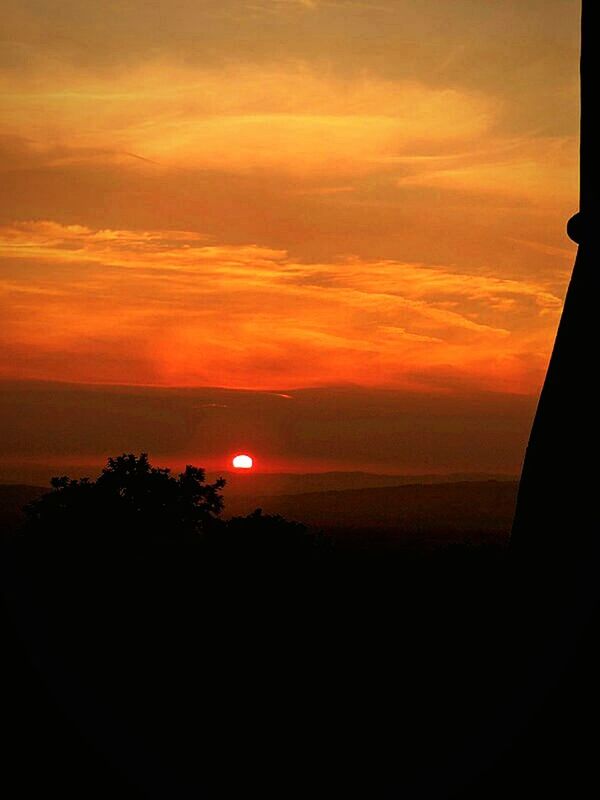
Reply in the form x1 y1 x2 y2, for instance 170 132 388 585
24 453 323 565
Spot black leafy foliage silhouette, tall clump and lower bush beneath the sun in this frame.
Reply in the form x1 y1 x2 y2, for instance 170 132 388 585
24 453 329 591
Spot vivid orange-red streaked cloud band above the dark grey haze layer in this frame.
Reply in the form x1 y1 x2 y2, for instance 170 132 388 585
0 220 561 391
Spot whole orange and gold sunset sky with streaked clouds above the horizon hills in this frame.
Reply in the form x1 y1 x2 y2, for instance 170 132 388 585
0 0 579 475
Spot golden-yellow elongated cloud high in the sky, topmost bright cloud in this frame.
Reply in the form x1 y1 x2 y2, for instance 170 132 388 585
4 62 495 174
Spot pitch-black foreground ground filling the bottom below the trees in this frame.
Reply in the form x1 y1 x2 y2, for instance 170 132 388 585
2 466 594 800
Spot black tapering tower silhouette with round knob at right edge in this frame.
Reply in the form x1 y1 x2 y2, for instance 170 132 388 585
511 0 600 586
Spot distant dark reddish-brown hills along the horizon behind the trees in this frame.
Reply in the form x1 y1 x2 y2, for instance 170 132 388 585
0 473 518 542
